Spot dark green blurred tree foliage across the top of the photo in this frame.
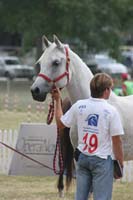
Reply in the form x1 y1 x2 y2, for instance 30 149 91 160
0 0 133 56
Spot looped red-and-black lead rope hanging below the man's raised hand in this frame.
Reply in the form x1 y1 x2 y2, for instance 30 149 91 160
47 94 64 174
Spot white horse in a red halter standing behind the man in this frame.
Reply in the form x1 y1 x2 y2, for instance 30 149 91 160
31 36 133 160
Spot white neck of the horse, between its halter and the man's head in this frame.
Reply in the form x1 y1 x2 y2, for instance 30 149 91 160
67 50 93 103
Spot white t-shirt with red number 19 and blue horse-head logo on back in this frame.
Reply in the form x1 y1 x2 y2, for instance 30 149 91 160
61 97 124 159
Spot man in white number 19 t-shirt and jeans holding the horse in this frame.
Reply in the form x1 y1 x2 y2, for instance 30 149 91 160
52 73 124 200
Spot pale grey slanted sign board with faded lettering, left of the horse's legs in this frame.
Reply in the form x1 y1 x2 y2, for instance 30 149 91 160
8 123 58 176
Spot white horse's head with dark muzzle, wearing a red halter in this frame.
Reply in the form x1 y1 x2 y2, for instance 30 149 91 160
31 35 71 101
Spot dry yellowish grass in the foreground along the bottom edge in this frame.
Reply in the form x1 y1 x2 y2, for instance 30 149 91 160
0 175 133 200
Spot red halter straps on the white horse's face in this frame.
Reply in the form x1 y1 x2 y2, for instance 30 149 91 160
38 47 70 83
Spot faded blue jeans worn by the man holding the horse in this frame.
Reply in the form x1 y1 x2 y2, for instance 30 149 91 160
75 153 113 200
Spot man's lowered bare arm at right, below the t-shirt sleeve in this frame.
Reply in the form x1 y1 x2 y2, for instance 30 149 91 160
112 135 124 167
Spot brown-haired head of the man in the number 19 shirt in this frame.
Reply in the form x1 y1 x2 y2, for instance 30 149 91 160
90 73 113 99
